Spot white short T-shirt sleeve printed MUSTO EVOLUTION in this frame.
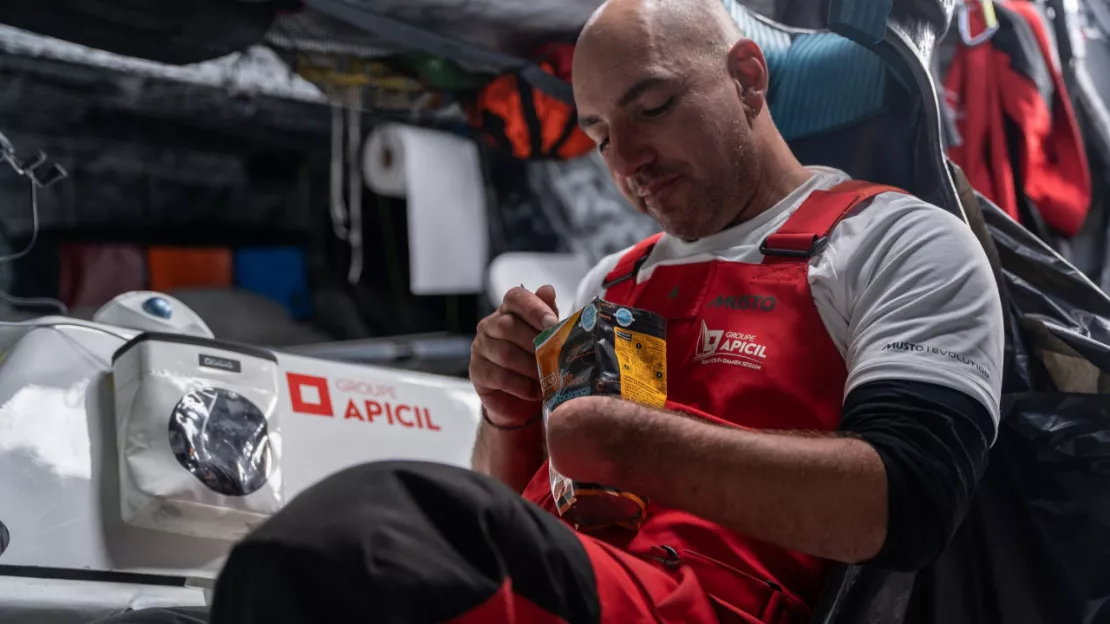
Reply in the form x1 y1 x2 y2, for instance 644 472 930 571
830 194 1005 433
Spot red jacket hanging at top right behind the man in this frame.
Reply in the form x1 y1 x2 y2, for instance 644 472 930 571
945 2 1091 236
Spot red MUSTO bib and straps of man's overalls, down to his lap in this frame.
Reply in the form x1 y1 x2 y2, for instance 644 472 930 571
524 181 902 622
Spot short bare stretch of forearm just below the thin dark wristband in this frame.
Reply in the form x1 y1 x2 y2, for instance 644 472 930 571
471 410 547 492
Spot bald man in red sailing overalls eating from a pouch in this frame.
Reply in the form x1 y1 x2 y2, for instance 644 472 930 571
204 0 1002 624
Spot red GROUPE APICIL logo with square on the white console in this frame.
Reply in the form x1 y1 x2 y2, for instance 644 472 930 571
285 373 440 431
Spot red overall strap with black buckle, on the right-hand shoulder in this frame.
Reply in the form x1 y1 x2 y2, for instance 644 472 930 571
759 180 907 263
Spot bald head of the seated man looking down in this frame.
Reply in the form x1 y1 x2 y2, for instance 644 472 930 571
573 0 775 239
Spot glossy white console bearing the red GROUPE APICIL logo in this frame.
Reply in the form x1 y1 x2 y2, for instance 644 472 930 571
0 318 480 622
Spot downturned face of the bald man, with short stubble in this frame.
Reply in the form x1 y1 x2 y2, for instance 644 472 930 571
574 32 758 240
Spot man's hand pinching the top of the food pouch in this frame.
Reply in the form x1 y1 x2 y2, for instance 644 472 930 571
471 286 558 426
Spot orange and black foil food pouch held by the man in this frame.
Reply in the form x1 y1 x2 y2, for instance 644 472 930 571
534 298 667 530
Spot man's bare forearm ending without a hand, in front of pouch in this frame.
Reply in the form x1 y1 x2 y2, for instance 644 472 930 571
548 401 887 563
